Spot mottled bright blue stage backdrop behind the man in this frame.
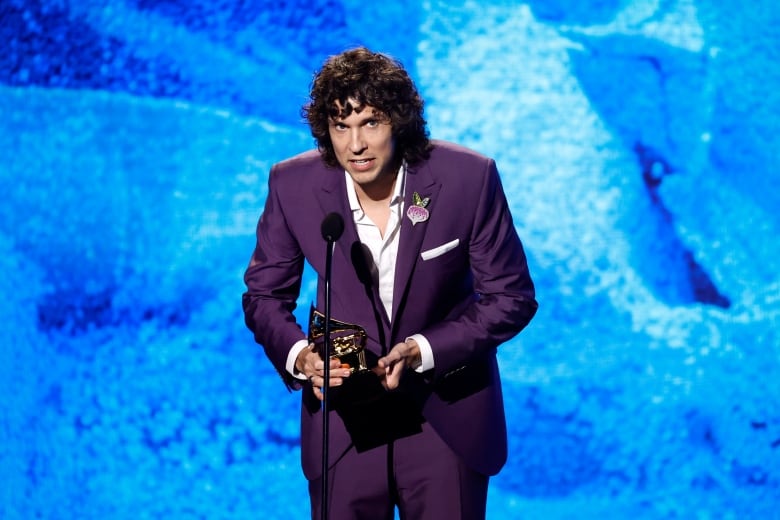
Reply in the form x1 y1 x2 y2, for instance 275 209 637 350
0 0 780 520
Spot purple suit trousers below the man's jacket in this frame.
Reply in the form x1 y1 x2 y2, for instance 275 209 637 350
309 423 488 520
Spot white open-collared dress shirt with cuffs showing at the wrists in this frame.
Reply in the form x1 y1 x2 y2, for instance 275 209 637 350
286 164 433 379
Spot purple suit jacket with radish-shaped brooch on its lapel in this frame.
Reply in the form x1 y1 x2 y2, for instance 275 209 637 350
243 141 537 479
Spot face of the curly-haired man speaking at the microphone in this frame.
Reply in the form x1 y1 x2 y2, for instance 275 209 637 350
328 99 400 197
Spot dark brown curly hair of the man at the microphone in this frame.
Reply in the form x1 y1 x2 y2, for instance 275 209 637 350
301 47 431 167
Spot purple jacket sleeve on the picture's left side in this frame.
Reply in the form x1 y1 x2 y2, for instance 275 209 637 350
242 167 306 389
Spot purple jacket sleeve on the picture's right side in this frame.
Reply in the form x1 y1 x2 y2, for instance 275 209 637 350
421 159 538 378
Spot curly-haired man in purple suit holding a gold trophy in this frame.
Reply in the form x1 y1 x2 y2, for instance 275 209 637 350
243 48 537 520
